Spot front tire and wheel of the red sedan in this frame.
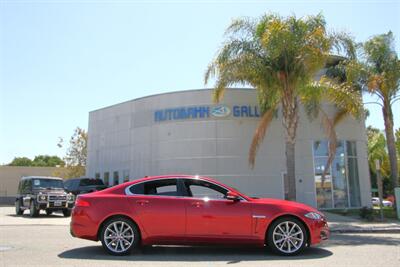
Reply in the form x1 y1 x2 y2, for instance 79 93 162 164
266 217 308 256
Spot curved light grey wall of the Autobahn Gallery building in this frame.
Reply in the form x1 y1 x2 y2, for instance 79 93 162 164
87 89 370 210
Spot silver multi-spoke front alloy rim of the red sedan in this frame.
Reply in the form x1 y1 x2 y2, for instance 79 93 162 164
272 221 304 254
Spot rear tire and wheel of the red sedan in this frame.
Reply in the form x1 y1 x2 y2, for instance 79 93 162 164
100 217 140 256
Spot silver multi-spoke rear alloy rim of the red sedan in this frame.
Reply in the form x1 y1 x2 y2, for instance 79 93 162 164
104 221 135 254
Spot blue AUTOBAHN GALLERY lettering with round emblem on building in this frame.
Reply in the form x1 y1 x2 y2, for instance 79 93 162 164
154 105 260 122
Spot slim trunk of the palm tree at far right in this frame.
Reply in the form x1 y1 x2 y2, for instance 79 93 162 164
382 101 399 188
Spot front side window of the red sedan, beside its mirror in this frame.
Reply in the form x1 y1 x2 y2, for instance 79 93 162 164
184 180 228 199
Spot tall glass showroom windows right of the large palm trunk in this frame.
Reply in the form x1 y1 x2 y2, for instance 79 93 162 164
313 140 360 209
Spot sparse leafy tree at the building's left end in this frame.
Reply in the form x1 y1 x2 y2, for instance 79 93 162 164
58 127 88 178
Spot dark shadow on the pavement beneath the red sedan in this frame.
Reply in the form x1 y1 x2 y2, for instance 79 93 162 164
58 246 332 264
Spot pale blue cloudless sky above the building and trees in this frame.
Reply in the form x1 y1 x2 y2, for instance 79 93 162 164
0 0 400 164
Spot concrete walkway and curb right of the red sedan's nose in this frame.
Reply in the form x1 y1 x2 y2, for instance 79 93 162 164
324 212 400 233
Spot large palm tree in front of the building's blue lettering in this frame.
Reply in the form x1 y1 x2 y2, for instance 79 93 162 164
205 14 361 200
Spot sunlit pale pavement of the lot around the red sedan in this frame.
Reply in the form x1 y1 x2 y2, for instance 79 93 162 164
0 207 400 267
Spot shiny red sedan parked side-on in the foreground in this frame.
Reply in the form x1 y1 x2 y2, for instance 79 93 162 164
71 175 329 255
